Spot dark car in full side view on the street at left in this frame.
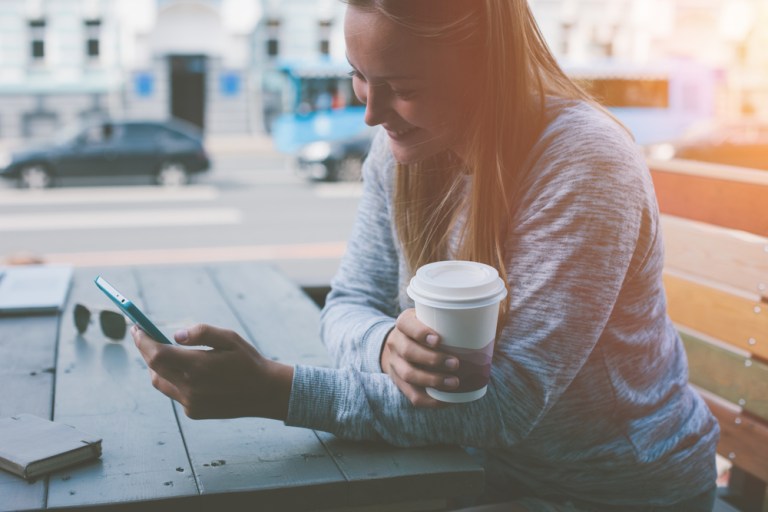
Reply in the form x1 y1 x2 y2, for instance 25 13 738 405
0 120 210 188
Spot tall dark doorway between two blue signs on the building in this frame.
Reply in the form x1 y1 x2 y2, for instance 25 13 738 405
168 55 206 130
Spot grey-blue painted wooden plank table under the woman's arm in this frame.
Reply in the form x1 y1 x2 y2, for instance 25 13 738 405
0 263 484 511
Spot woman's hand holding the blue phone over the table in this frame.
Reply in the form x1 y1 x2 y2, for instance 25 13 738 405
131 324 293 420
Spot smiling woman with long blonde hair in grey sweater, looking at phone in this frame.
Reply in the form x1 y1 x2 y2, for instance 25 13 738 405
133 0 718 512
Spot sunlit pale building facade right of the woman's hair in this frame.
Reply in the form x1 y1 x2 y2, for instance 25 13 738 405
530 0 768 119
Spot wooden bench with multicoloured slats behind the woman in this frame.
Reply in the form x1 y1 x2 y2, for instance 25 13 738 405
649 161 768 512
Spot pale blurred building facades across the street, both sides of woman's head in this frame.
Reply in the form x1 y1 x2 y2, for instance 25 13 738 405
0 0 768 139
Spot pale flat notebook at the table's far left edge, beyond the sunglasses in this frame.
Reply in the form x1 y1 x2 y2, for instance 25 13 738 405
0 265 73 314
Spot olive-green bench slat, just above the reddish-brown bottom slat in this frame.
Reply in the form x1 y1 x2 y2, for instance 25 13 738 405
680 328 768 420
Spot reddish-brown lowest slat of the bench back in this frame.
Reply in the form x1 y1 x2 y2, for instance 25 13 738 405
696 387 768 481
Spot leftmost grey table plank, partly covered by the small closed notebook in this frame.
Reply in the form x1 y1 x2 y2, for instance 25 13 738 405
0 315 59 511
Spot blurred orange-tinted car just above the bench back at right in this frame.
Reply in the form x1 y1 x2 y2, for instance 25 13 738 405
646 121 768 170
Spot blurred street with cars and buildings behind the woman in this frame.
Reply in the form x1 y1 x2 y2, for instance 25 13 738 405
0 0 768 287
